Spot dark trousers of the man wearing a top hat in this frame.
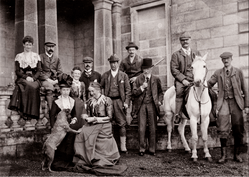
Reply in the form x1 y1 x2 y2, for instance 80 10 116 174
138 103 157 153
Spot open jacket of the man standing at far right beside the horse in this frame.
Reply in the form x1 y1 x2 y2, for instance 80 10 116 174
208 67 249 111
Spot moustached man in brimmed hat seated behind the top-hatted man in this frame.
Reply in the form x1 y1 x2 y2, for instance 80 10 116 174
119 42 143 123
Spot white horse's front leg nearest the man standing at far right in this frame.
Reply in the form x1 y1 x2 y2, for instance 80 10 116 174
201 116 212 162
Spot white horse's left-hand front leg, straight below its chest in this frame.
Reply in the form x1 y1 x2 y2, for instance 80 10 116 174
190 116 198 162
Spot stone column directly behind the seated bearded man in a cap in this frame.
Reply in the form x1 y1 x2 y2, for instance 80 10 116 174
38 0 59 56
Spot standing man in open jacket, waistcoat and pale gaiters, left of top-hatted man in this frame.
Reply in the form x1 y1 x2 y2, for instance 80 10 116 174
100 54 131 153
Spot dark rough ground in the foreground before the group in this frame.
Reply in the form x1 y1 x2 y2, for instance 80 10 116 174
0 147 249 176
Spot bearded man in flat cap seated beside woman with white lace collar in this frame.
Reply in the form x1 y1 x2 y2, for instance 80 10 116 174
40 41 63 110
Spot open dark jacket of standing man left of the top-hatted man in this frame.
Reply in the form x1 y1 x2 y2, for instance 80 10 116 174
100 70 131 105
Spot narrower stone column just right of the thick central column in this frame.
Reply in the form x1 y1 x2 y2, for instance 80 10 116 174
112 0 122 59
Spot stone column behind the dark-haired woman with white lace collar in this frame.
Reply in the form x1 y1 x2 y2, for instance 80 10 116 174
15 0 38 54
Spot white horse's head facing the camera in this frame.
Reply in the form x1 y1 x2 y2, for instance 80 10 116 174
192 54 207 87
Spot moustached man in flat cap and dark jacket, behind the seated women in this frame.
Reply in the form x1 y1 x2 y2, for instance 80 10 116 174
79 57 101 100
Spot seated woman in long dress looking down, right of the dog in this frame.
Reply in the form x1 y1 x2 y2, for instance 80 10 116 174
73 82 126 174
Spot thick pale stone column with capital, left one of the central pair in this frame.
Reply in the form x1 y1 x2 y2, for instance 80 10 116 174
92 0 113 74
